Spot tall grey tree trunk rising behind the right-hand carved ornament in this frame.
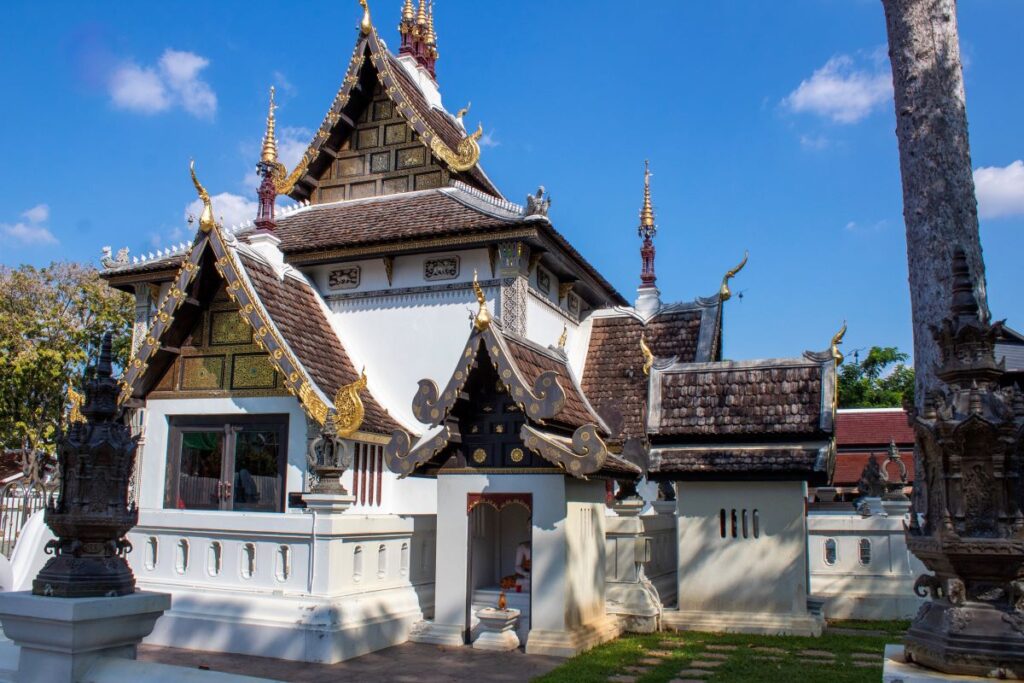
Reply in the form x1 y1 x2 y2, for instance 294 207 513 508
882 0 988 409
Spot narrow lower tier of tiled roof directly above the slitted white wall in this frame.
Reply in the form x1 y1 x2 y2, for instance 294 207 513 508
650 445 828 479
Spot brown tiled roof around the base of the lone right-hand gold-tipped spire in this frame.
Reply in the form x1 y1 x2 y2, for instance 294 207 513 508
582 308 702 441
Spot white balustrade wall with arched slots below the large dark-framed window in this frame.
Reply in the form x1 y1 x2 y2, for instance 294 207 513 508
128 510 435 663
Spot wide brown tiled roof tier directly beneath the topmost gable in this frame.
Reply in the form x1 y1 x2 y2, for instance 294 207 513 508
275 189 522 255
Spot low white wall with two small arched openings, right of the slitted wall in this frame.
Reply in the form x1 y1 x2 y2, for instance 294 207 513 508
807 503 930 620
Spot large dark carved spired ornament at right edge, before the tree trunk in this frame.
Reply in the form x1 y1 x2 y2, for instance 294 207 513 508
906 252 1024 678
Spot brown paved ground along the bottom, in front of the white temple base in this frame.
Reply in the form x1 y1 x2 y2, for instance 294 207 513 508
138 643 561 683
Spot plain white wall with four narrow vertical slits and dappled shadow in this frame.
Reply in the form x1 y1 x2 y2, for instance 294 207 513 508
677 481 807 614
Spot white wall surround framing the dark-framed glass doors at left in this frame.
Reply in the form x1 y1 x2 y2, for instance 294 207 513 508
138 396 306 509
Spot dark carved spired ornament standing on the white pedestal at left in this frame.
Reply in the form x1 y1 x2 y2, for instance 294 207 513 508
32 335 138 598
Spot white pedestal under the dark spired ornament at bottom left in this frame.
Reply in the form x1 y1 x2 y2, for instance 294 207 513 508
0 592 171 683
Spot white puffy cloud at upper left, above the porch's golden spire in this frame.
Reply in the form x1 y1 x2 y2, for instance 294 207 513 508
109 49 217 119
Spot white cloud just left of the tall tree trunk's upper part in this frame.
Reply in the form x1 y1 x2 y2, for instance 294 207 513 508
782 54 892 124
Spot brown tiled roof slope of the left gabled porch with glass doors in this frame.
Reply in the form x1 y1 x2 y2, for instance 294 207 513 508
237 250 398 434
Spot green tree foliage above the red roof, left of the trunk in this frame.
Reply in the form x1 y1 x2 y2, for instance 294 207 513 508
839 346 913 408
